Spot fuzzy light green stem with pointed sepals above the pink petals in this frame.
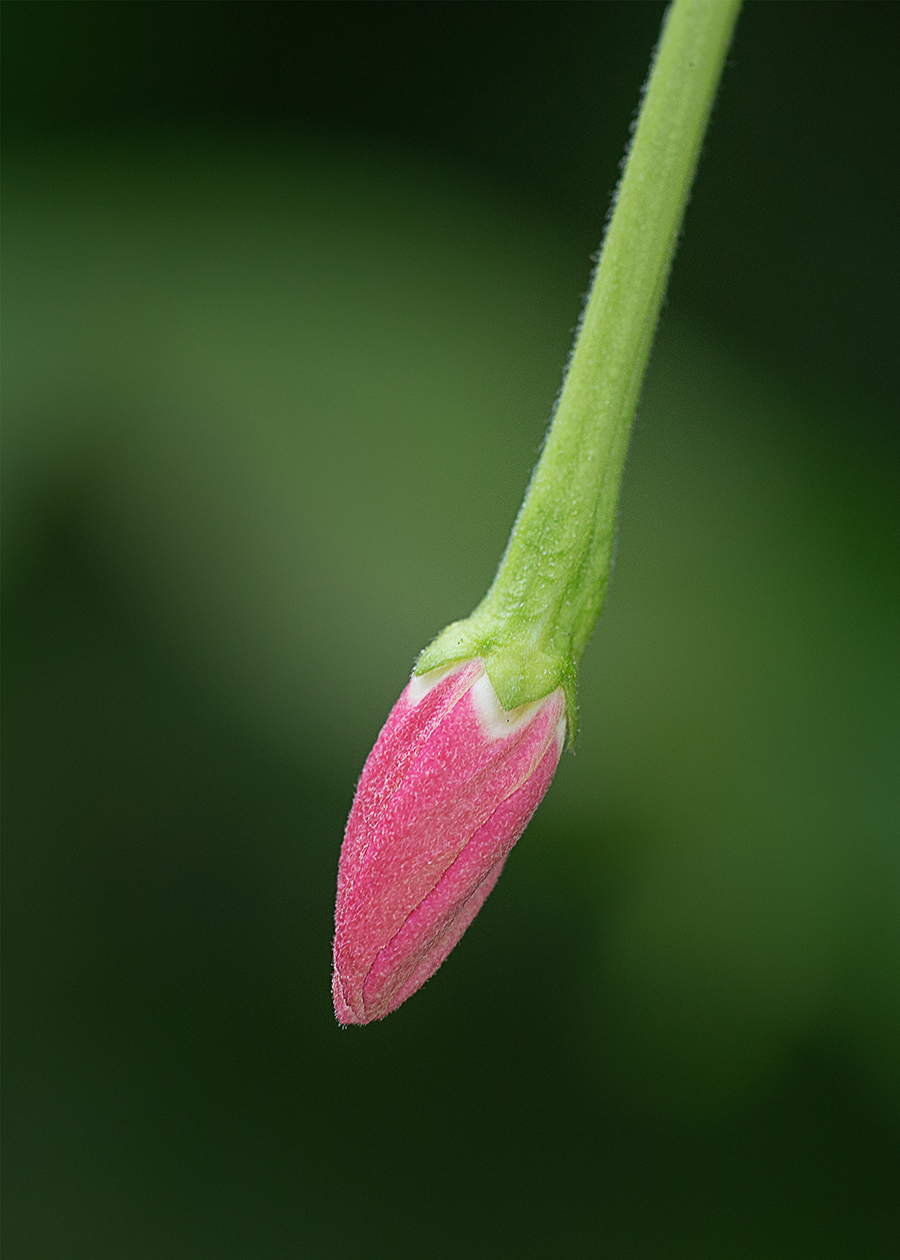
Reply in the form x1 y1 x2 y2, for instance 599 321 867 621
416 0 740 735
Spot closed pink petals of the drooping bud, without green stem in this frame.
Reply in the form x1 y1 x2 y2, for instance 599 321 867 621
333 659 566 1024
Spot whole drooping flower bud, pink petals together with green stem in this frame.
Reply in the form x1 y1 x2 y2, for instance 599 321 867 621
333 0 740 1024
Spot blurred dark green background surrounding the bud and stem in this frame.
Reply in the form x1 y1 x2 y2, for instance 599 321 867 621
4 3 900 1260
